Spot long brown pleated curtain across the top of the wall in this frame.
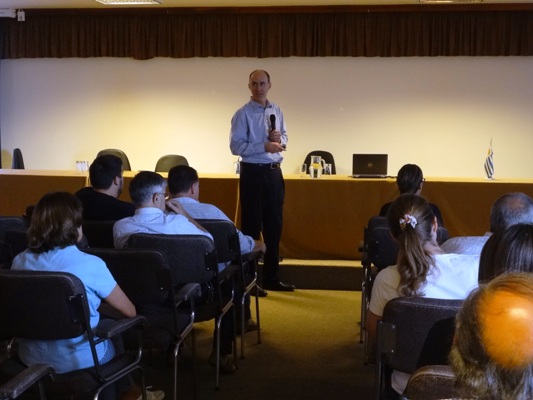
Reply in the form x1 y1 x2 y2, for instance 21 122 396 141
0 5 533 60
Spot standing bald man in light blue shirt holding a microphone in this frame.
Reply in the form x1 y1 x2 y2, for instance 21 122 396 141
230 70 294 292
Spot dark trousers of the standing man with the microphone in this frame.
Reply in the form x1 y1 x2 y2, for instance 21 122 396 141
239 163 285 281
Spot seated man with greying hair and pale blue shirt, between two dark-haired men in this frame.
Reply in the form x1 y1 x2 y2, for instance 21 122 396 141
113 171 236 374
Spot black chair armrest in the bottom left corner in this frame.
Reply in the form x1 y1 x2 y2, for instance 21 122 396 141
0 364 52 400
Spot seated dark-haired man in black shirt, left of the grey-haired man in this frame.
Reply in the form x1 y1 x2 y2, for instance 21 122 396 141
76 154 135 221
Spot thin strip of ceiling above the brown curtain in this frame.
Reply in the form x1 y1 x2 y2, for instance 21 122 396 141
0 0 533 9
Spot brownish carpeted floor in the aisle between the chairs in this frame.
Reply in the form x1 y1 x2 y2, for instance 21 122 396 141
141 290 373 400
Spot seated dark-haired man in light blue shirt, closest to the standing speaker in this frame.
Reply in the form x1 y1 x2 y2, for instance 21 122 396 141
168 165 266 331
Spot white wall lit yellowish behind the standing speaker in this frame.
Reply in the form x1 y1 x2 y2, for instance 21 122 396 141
0 57 533 178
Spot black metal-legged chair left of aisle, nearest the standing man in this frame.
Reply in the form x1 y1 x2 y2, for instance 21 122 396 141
196 219 261 358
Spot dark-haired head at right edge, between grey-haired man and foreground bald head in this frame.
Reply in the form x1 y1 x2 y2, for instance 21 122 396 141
479 224 533 283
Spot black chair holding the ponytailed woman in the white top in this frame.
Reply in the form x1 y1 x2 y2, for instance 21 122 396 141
375 297 463 400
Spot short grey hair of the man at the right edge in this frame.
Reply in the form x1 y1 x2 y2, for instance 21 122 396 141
490 192 533 232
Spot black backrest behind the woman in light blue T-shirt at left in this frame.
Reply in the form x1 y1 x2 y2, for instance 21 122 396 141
0 270 88 340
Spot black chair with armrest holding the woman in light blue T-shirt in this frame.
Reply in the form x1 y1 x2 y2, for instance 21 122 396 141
0 270 146 399
